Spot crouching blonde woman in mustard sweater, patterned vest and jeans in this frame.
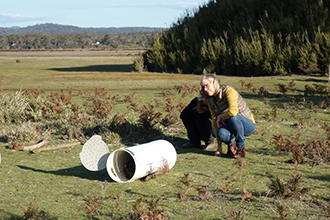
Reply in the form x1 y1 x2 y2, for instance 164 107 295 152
200 73 256 158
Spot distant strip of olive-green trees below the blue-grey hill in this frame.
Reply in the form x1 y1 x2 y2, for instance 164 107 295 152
0 32 156 50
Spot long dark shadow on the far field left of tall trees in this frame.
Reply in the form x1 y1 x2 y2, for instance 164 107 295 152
47 64 132 72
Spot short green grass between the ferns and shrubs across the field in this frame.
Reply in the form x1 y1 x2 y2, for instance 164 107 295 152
0 50 330 219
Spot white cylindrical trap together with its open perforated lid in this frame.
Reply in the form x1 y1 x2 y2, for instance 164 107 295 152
80 135 177 183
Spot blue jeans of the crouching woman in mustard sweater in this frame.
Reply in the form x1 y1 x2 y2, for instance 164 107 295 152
217 114 256 148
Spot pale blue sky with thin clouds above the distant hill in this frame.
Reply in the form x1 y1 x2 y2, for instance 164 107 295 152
0 0 207 27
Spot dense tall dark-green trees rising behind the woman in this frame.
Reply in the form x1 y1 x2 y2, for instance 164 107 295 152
141 0 330 76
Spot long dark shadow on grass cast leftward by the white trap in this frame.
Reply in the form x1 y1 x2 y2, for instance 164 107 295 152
18 165 113 182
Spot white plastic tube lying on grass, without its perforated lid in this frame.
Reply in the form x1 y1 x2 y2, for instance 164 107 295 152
106 140 177 183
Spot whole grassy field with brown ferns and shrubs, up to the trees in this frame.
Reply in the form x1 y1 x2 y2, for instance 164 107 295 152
0 51 330 220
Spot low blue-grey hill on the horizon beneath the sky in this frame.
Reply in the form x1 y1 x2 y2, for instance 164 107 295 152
0 23 162 36
